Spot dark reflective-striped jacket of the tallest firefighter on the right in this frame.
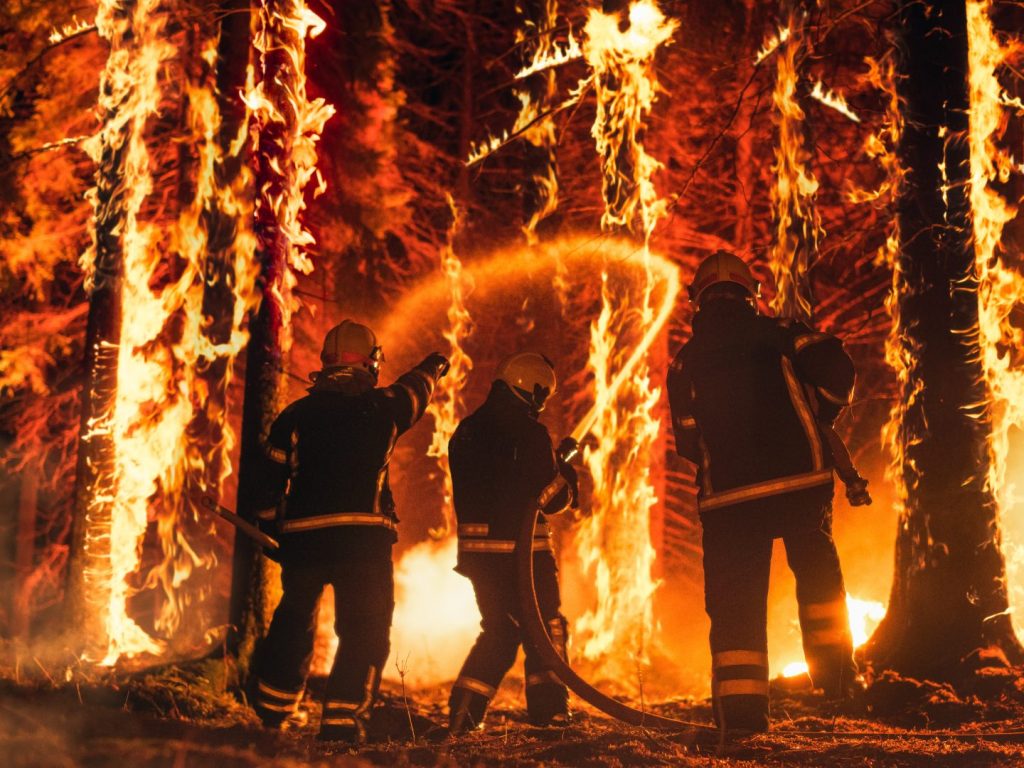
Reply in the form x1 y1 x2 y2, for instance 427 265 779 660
668 300 854 513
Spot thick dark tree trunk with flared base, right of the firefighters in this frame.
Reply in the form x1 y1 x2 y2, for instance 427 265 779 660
865 0 1022 679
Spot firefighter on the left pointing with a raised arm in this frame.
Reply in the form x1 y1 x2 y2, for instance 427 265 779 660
251 321 449 743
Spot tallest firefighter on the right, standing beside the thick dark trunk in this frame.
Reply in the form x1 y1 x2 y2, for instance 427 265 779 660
668 251 866 732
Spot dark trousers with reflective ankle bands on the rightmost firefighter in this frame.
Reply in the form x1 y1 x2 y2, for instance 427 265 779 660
701 495 857 731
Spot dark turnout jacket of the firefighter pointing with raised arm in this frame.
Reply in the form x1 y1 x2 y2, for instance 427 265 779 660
260 357 438 547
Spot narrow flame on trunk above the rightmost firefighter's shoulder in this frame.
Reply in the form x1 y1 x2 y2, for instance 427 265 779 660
769 12 824 317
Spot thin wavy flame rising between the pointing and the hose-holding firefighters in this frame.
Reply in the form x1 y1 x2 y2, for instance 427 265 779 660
427 195 473 539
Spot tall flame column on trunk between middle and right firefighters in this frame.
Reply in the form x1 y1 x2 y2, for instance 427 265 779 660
575 0 678 680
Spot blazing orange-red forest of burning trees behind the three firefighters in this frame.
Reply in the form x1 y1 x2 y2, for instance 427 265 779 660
0 0 1024 757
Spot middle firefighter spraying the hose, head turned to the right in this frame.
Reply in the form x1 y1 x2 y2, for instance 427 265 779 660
449 352 578 734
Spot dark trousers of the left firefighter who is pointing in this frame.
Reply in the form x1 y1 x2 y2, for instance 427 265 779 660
253 543 394 741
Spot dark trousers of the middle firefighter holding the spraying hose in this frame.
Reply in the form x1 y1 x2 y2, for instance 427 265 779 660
449 552 568 730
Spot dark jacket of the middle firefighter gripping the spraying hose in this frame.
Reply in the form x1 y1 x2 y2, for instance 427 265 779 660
449 382 575 572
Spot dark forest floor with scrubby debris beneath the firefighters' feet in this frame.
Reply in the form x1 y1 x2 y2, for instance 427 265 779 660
0 656 1024 768
